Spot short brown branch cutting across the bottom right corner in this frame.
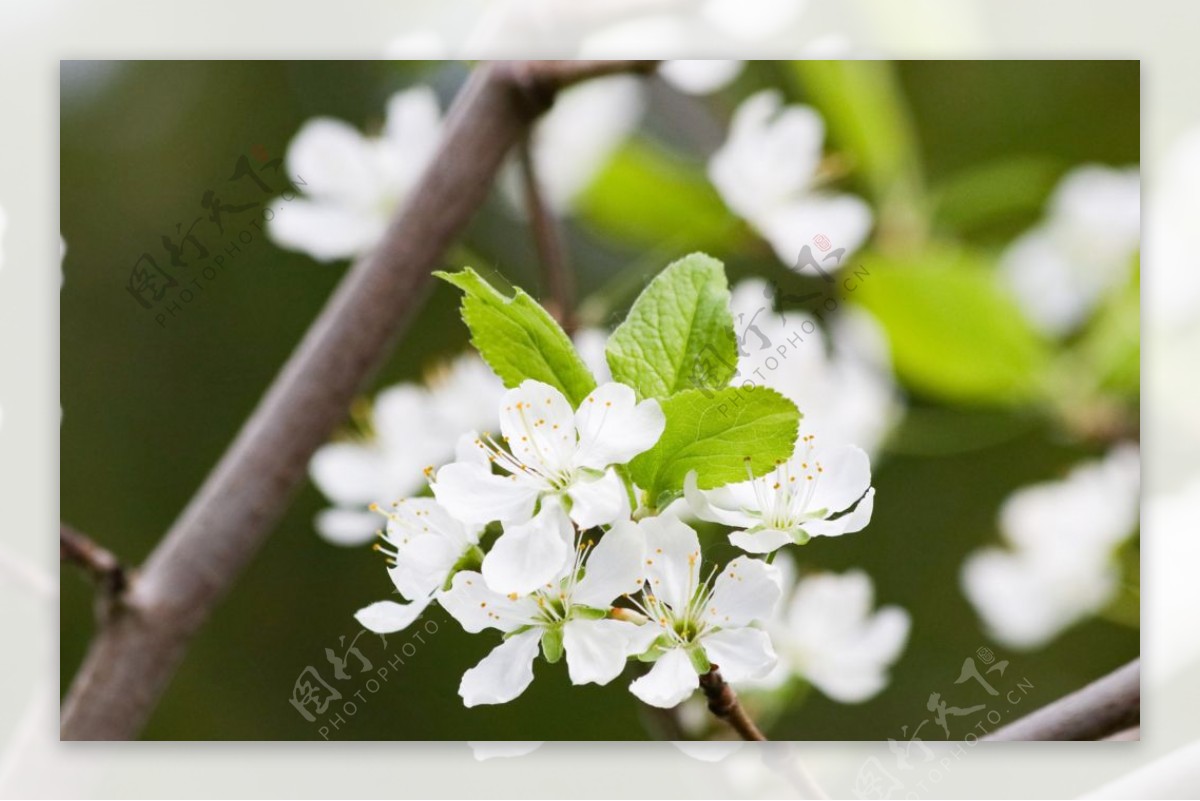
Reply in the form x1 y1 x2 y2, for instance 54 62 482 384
983 660 1141 741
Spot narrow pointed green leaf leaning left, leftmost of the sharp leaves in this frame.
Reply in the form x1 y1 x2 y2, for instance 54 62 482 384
433 267 596 406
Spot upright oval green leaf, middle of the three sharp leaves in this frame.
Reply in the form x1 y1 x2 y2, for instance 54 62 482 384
606 253 738 398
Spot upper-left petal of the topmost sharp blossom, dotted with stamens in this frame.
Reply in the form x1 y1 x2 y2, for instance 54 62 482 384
500 380 576 475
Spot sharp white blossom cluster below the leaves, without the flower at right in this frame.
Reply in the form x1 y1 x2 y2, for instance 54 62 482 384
356 380 806 706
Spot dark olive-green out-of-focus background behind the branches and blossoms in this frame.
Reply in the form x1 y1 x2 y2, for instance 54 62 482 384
60 61 1139 740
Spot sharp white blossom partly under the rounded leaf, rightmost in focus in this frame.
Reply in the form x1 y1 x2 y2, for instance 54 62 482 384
684 434 875 554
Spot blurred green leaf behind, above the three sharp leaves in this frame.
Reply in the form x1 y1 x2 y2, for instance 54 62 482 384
576 138 745 248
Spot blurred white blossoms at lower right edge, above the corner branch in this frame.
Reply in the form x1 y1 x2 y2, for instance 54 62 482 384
961 445 1140 649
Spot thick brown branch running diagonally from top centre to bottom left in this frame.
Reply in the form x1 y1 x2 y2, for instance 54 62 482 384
61 61 653 740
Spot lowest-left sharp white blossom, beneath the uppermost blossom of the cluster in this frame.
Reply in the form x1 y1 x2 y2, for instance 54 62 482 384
440 522 646 706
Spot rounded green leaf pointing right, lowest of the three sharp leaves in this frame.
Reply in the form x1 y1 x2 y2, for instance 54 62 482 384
629 387 800 505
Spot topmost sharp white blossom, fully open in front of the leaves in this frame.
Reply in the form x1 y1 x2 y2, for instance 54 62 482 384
433 380 666 592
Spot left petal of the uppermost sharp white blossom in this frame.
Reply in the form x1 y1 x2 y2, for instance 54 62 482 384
433 462 539 524
